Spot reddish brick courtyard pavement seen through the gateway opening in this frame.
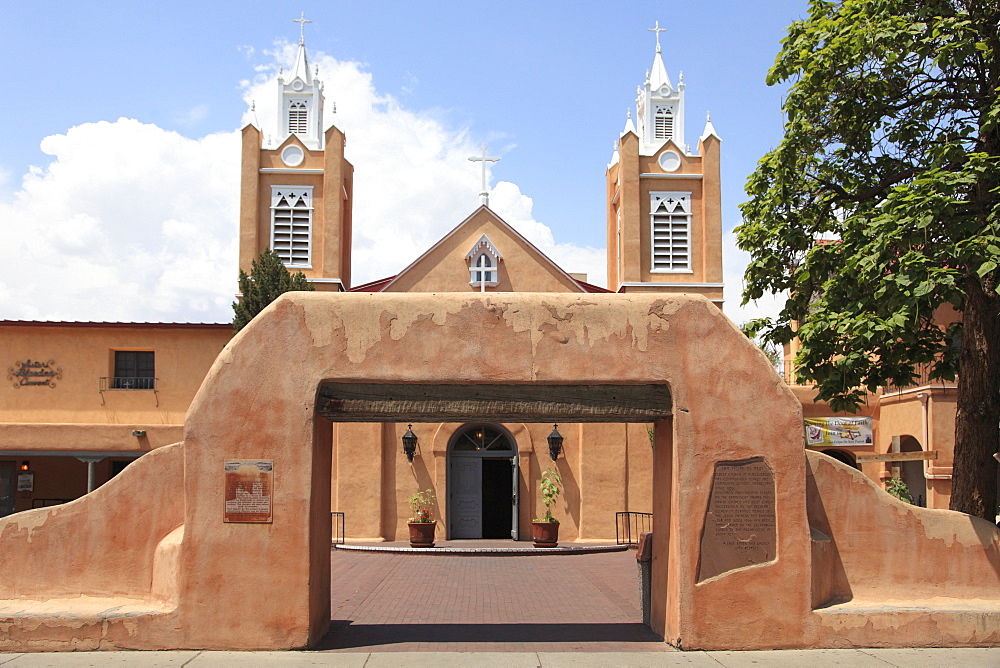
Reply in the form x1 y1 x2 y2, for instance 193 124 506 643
319 551 672 652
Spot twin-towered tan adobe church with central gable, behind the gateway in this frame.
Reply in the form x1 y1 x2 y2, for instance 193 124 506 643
240 26 722 540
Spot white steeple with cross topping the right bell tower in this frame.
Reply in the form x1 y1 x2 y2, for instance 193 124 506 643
635 21 685 155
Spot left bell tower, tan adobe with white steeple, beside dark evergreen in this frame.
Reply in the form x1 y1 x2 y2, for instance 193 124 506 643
240 14 354 291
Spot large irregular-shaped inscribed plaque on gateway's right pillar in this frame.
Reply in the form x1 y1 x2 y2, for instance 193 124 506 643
698 457 777 582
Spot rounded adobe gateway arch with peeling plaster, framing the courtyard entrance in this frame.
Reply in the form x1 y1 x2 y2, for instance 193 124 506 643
178 293 809 648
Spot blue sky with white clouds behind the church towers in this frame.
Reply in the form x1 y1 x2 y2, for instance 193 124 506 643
0 0 806 321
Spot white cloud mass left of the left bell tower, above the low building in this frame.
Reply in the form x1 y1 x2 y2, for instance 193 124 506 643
0 118 239 320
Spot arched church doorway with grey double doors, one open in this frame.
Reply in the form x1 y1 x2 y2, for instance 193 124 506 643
447 424 518 540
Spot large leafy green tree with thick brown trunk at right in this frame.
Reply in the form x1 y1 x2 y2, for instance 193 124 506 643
738 0 1000 519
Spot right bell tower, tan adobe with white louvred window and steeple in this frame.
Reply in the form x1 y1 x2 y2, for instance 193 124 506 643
605 21 723 307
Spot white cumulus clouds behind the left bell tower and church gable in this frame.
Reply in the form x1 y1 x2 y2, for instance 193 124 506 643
0 44 640 322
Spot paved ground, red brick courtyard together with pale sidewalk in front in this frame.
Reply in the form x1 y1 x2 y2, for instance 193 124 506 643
0 552 1000 668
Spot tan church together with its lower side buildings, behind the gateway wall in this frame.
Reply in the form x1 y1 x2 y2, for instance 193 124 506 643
0 20 976 541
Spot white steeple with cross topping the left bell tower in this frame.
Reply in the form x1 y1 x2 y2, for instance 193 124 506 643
275 12 323 150
